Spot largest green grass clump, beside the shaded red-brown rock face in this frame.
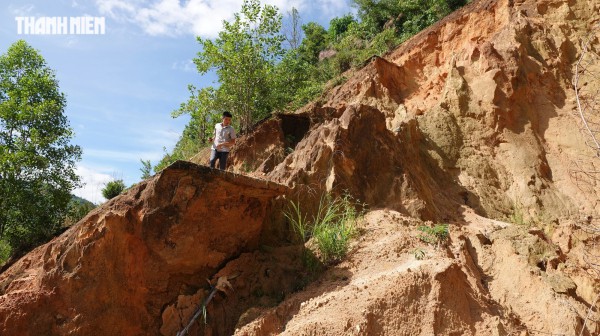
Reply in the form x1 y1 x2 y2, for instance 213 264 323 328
285 194 362 263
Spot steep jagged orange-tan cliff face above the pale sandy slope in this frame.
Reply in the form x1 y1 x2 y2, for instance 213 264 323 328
233 0 600 223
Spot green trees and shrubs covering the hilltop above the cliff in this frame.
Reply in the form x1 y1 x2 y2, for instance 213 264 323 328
155 0 468 171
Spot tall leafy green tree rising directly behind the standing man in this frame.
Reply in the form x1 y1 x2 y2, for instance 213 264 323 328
191 0 285 132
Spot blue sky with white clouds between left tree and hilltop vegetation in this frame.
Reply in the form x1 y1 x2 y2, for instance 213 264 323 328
0 0 353 203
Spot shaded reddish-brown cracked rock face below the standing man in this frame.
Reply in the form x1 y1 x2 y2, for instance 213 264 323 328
0 162 286 335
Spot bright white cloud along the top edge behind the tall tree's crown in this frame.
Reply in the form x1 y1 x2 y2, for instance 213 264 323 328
96 0 348 38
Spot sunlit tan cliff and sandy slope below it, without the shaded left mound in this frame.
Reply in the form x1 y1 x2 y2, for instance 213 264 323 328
225 1 600 335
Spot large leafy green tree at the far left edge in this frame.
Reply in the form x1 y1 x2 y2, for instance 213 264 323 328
0 40 81 253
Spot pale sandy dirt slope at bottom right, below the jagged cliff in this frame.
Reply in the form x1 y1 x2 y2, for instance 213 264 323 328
236 208 600 335
